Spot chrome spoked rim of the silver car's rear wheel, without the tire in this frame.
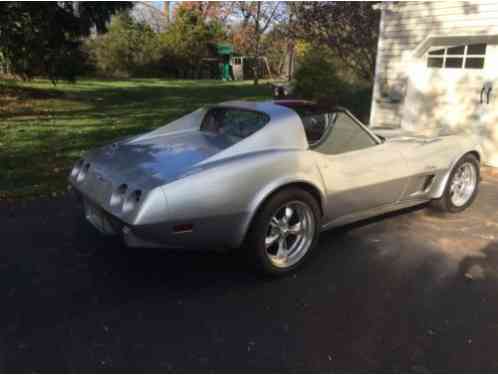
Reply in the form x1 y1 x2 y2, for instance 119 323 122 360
265 201 316 268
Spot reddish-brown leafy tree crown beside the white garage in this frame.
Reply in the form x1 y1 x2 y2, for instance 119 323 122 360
289 1 380 81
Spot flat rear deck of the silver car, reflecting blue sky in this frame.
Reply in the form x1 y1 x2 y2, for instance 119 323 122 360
88 130 235 189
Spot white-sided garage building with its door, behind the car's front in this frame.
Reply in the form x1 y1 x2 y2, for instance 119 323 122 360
370 1 498 167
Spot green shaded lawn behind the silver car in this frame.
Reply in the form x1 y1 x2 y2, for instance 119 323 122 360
0 79 271 200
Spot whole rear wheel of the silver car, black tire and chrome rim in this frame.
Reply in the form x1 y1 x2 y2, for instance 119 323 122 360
246 188 320 276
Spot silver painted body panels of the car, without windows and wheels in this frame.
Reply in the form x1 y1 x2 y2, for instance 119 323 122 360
70 102 480 248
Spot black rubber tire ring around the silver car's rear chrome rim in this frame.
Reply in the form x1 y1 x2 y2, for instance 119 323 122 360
247 188 321 276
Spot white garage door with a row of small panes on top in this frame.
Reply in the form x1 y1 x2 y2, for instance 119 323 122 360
402 38 498 166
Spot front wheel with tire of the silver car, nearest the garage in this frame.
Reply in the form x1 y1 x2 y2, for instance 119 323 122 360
431 154 480 213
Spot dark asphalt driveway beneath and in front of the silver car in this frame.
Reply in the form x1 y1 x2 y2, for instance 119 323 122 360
0 173 498 372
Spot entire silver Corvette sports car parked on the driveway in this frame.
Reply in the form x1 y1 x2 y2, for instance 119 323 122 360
69 100 480 274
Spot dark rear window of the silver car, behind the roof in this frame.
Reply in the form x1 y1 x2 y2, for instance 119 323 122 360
201 108 270 142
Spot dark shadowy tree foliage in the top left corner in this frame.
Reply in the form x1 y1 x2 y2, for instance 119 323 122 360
0 1 133 84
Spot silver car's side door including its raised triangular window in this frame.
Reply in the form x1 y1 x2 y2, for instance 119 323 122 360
312 112 410 222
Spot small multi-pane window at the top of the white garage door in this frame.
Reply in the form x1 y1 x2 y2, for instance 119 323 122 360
427 43 486 69
